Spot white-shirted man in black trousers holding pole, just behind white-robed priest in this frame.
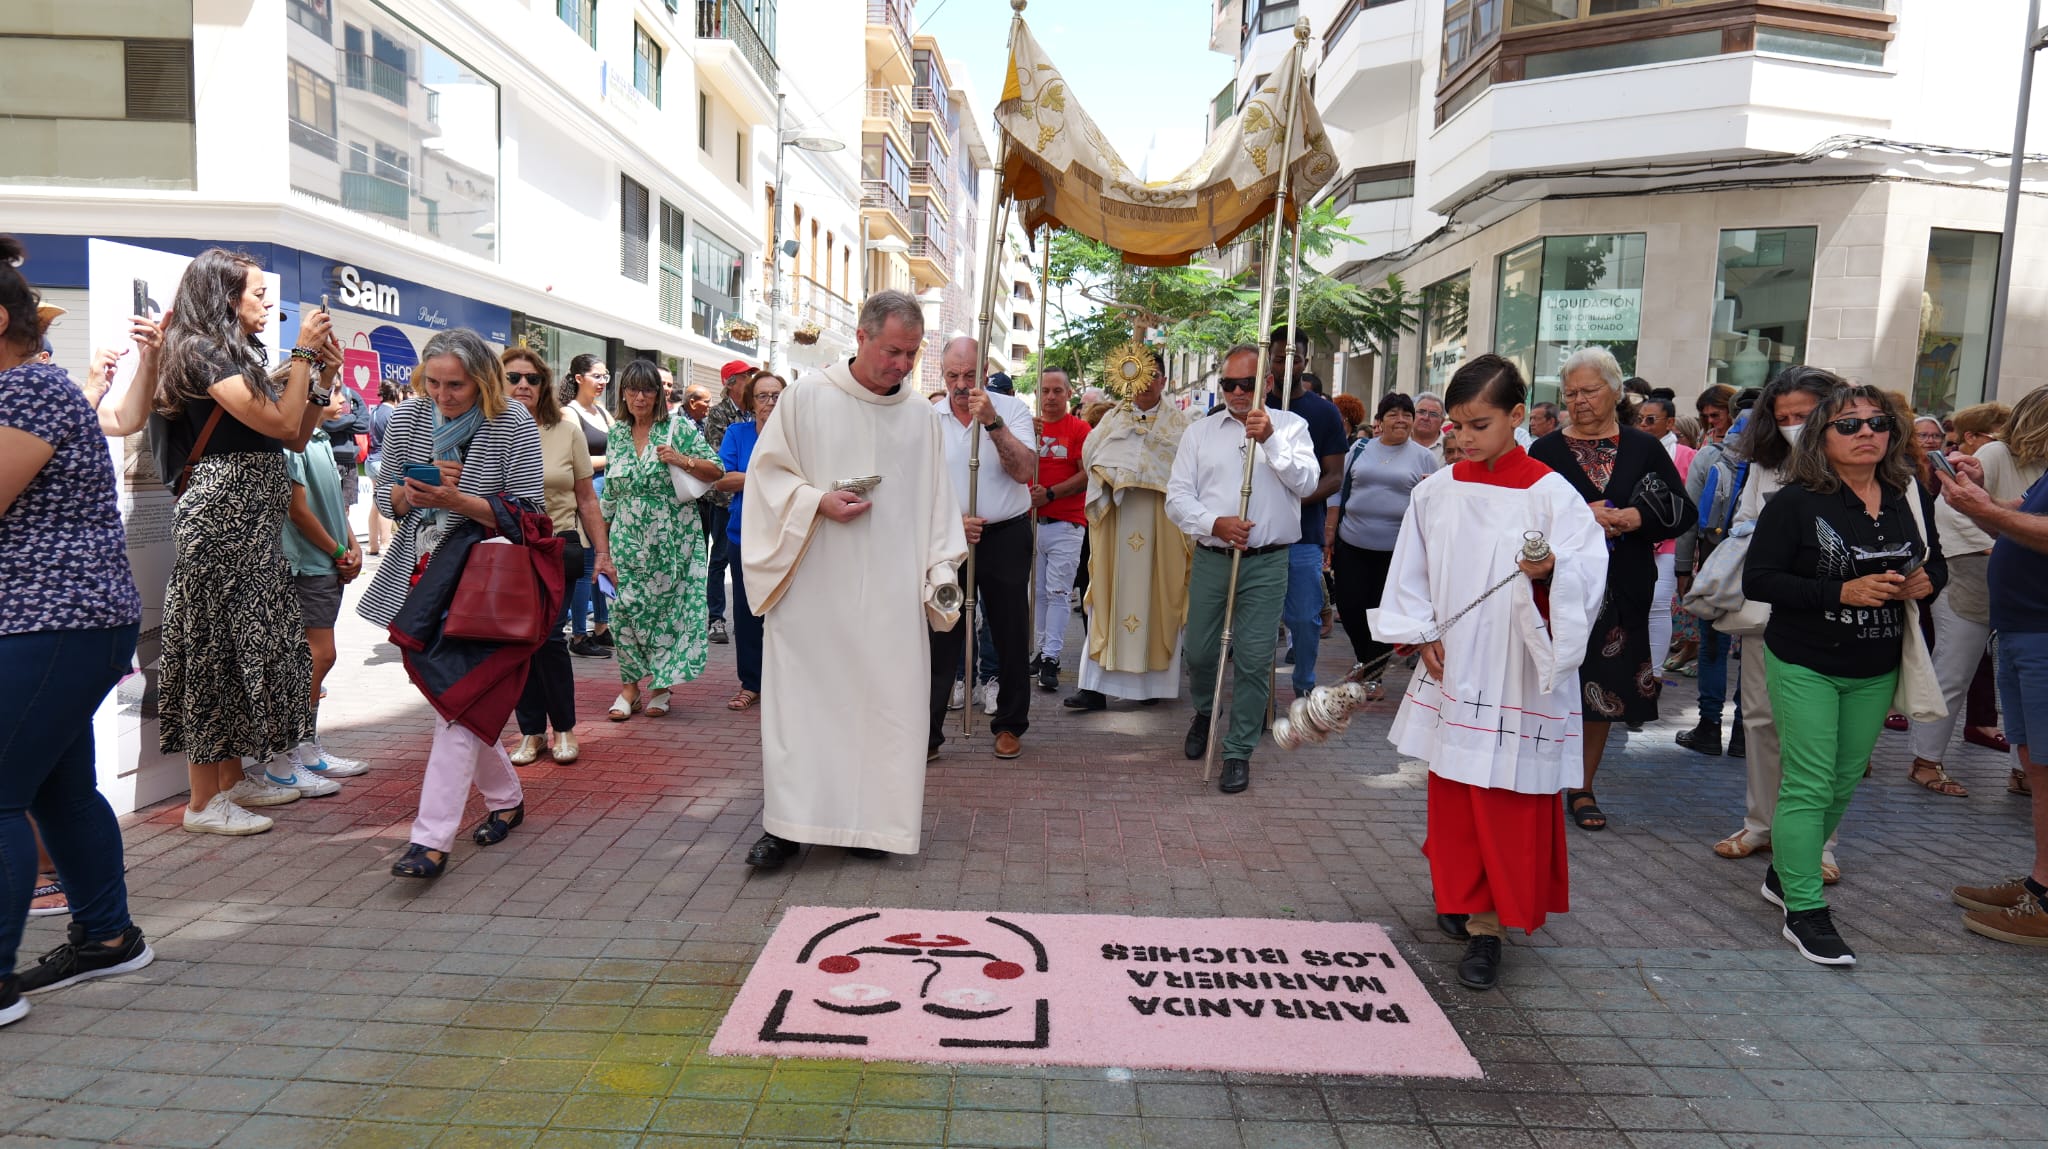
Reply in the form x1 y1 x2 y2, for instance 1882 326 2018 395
926 336 1040 758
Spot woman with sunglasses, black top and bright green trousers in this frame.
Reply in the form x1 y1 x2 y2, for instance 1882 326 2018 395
1743 387 1948 965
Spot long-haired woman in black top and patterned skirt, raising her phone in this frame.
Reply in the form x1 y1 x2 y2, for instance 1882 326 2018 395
156 248 342 836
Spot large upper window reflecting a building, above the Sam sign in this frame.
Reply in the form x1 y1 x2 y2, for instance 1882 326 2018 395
287 0 500 260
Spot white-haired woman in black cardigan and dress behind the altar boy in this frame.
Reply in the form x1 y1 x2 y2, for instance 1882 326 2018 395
1530 346 1698 829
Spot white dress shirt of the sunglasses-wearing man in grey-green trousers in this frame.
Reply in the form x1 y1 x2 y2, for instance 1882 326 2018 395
1165 408 1323 547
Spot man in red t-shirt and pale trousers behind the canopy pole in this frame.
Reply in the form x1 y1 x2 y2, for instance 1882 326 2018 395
1030 371 1087 690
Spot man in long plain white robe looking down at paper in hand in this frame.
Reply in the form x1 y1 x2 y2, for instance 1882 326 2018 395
739 291 967 868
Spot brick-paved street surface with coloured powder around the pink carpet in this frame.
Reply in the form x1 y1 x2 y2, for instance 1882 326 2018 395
0 565 2048 1149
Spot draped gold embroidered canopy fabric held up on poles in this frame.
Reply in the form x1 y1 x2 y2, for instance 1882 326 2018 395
995 20 1337 266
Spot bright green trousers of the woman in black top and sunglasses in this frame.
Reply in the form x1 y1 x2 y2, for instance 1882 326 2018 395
1763 649 1898 909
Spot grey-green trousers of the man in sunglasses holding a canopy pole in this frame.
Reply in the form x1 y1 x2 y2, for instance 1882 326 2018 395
1182 547 1286 760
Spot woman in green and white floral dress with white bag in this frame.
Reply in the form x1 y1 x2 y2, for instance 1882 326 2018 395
598 360 725 723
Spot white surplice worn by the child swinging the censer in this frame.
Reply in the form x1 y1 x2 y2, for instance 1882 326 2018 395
1366 449 1608 795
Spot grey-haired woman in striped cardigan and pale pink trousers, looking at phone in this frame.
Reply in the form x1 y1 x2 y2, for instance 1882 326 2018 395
356 328 547 879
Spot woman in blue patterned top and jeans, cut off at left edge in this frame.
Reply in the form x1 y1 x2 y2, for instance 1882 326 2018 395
0 236 156 1026
